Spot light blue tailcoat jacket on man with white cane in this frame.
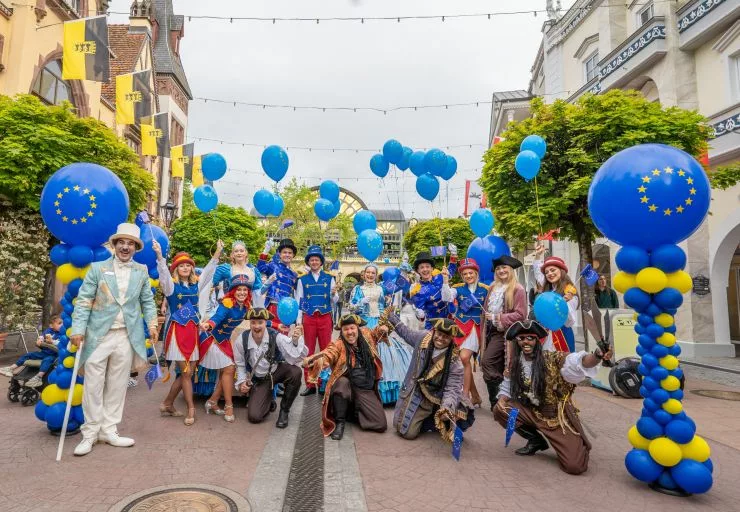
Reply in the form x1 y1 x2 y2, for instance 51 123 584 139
71 258 157 364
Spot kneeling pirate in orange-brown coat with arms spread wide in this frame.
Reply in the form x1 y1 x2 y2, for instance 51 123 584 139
303 314 388 440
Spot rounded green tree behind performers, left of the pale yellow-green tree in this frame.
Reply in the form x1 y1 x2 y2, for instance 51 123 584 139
170 204 265 266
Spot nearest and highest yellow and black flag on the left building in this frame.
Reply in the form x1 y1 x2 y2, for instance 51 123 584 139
62 15 110 82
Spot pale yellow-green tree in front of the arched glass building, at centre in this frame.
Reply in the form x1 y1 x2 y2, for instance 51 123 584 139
265 178 356 258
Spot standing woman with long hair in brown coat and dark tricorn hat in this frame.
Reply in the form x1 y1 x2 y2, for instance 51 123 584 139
480 255 527 408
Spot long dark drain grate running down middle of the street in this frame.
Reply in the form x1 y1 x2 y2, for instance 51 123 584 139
283 396 324 512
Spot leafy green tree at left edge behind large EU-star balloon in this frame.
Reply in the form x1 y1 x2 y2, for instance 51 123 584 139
0 95 155 213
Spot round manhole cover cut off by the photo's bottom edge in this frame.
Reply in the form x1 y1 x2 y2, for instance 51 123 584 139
111 485 250 512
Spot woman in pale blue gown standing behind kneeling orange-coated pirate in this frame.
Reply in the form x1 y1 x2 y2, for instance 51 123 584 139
349 263 411 404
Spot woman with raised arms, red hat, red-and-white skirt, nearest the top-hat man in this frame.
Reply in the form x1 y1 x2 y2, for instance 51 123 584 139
152 240 224 426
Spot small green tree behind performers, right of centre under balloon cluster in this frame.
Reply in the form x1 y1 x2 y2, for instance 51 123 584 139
403 219 475 266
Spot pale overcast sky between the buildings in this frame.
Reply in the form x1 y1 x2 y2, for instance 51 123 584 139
110 0 546 219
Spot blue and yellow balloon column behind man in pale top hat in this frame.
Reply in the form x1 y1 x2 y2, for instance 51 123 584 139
35 163 129 433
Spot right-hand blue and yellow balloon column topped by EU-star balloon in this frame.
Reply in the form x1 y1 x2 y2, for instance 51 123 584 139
588 144 713 495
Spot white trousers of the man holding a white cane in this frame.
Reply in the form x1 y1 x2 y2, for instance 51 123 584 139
81 327 134 439
